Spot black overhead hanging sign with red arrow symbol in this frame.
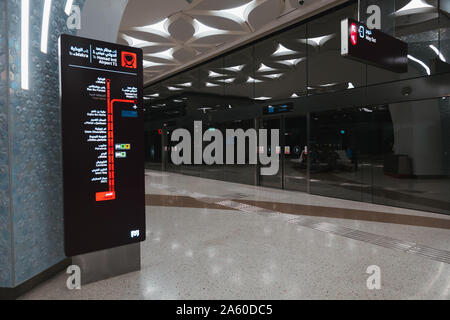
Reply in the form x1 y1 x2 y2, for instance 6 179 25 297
341 19 408 73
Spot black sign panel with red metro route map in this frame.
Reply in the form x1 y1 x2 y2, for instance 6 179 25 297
60 35 145 257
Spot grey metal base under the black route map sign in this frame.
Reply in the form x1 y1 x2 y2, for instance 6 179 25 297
72 243 141 285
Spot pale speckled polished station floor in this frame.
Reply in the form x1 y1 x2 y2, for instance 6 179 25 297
23 171 450 299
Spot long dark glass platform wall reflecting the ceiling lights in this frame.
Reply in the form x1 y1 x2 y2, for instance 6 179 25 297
145 0 450 214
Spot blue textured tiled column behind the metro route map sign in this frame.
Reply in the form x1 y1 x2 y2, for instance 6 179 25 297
0 0 85 287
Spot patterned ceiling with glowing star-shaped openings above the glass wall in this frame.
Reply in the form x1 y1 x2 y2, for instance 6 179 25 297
118 0 333 83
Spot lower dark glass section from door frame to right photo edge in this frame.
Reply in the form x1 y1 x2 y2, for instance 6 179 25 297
310 98 450 213
